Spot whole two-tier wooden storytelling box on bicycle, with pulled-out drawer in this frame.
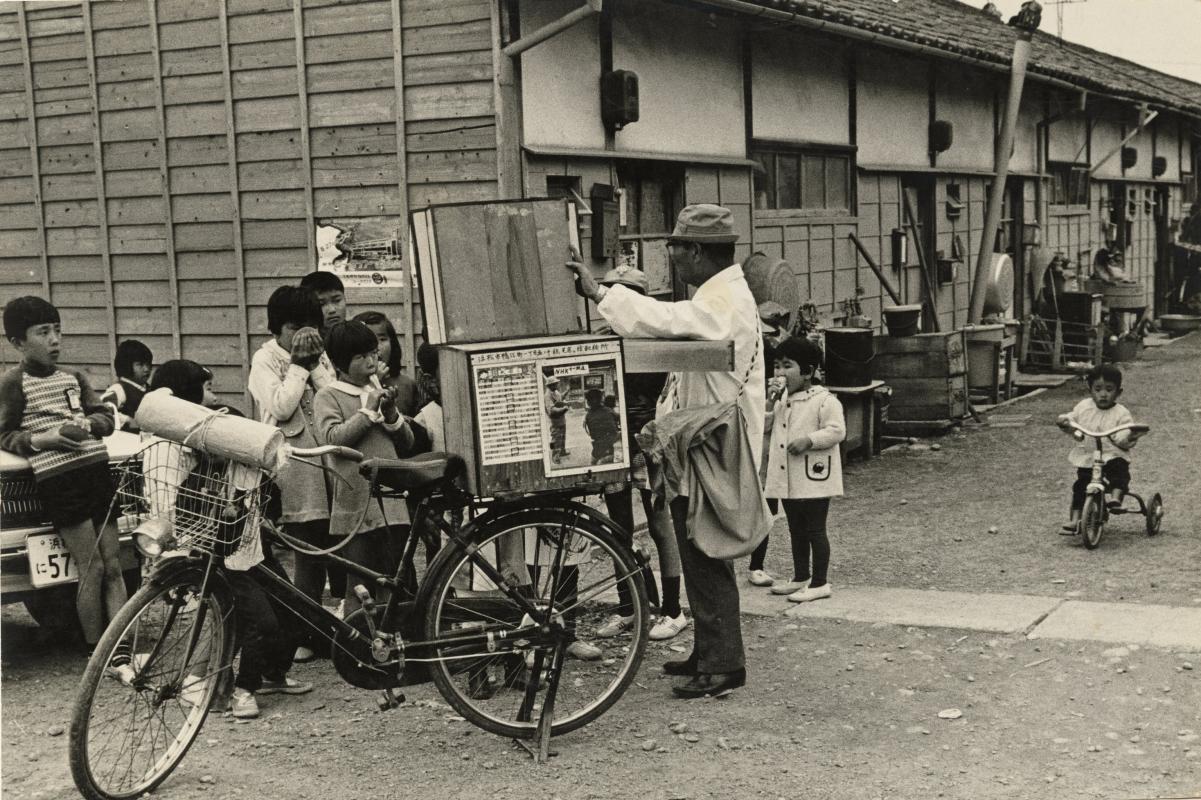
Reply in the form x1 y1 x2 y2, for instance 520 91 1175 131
412 199 734 497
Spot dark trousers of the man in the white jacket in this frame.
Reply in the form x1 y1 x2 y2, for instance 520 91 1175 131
671 497 746 673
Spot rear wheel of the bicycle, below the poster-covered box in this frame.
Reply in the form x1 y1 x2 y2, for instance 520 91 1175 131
425 508 650 739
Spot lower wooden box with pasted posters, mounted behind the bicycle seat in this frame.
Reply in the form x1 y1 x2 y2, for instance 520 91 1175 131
438 334 629 497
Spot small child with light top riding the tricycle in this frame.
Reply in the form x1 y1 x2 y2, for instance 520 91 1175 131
1056 364 1139 533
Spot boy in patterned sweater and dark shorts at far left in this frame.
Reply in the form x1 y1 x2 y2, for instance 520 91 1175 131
0 297 133 667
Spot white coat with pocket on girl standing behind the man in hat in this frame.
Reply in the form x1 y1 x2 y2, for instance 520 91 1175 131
763 386 847 500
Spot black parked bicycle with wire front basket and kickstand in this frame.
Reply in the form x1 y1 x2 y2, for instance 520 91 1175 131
70 441 649 800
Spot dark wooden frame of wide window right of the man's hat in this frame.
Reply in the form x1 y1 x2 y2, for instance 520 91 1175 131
747 139 859 219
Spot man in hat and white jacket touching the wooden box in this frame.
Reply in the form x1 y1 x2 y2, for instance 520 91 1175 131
568 203 766 699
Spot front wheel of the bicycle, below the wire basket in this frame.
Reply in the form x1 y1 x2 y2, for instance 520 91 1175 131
70 559 234 800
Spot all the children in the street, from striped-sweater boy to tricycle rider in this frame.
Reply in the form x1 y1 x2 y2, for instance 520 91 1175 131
0 264 1137 717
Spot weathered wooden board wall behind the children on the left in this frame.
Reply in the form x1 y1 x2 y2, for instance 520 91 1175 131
0 0 497 400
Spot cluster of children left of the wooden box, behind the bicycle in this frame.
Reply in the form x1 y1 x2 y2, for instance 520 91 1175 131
0 271 442 717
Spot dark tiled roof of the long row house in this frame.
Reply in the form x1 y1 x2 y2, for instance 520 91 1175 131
720 0 1201 117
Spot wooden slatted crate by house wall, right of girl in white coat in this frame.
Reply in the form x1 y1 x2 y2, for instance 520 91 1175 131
872 330 968 432
